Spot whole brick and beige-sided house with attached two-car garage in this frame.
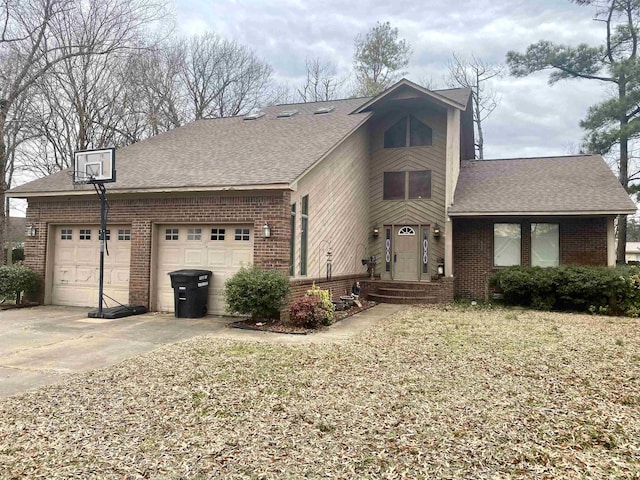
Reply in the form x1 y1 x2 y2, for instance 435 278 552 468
9 80 635 313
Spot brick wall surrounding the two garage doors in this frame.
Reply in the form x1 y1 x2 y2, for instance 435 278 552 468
25 191 291 307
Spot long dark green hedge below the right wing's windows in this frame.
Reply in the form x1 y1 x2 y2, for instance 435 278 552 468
490 265 640 316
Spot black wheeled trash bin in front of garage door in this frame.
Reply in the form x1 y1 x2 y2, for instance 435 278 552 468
169 270 212 318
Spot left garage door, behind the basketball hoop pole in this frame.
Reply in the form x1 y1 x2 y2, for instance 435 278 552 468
51 225 131 307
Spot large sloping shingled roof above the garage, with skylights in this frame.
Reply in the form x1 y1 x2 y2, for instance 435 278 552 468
11 98 371 196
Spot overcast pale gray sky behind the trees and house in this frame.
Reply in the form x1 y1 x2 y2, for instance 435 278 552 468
174 0 607 158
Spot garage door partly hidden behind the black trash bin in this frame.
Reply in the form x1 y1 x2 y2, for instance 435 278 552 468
156 225 253 314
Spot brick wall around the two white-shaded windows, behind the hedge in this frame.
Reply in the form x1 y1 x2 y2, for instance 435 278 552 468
453 217 607 300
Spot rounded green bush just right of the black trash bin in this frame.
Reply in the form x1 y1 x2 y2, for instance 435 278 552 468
224 266 289 319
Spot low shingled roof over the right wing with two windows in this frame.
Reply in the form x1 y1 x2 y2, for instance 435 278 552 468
449 155 636 216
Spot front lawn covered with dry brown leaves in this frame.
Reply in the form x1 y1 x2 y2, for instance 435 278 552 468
0 307 640 479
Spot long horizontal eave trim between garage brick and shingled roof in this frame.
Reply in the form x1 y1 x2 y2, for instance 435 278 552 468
5 183 291 199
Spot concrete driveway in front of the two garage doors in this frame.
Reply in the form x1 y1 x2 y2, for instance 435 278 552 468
0 306 232 397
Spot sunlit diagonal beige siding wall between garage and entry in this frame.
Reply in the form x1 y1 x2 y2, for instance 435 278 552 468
291 125 373 278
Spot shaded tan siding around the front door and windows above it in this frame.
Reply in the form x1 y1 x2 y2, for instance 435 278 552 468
369 110 447 278
